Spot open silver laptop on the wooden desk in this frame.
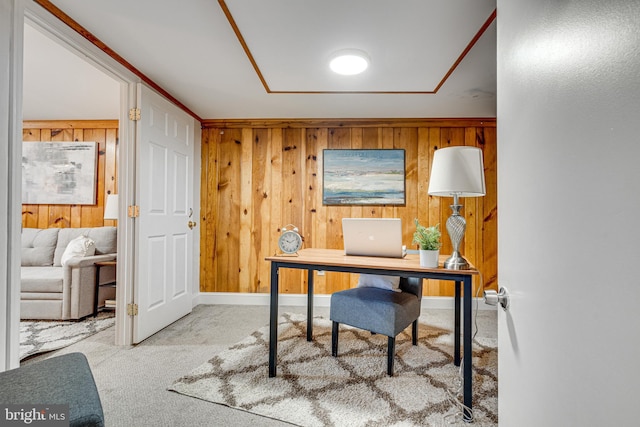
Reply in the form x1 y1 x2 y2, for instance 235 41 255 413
342 218 406 258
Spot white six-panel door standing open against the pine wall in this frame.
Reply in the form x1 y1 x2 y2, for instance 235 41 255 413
133 84 195 343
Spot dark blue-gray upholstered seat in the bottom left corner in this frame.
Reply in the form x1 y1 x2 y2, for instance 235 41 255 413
0 353 104 427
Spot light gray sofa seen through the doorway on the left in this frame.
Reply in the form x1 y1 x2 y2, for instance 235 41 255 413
20 227 117 320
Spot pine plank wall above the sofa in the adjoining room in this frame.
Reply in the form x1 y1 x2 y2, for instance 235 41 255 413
22 120 118 228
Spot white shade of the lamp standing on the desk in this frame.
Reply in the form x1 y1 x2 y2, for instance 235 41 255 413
428 146 486 197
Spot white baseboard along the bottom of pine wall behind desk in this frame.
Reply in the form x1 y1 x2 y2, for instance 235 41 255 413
194 292 496 310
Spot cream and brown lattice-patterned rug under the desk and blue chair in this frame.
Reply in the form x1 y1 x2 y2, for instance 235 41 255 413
169 314 498 427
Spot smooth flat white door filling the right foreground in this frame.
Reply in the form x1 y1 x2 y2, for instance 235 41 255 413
498 0 640 427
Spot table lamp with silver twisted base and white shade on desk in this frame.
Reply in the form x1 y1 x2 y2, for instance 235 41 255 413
427 146 486 270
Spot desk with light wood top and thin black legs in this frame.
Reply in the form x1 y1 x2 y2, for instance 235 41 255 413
265 248 478 420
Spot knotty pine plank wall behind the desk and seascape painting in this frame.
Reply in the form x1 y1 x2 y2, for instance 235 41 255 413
200 120 497 296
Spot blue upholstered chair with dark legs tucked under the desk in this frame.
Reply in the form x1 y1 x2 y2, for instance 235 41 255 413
329 277 422 376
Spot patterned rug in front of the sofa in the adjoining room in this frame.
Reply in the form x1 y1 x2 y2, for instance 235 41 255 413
20 310 116 360
